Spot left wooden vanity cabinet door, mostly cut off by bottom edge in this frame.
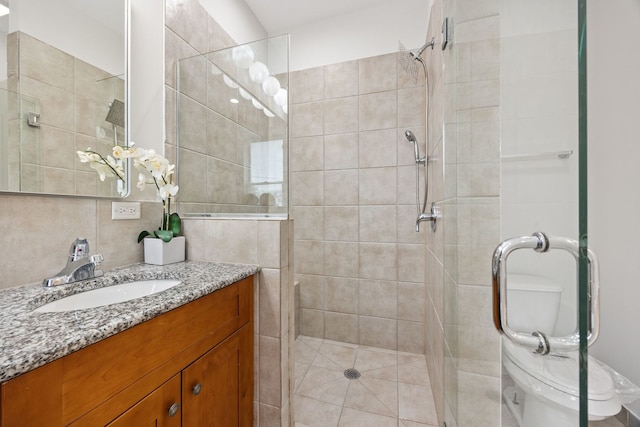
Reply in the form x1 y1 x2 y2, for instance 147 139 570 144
107 374 182 427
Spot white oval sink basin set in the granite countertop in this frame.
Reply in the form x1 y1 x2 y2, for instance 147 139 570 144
34 279 182 313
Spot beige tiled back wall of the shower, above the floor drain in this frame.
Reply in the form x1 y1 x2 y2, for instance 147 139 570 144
290 54 426 353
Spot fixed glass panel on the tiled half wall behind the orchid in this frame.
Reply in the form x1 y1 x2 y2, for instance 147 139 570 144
177 36 289 216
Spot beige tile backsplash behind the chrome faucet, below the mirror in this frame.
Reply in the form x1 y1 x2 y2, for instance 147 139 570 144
0 194 161 288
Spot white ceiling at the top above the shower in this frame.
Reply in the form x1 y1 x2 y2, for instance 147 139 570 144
244 0 388 34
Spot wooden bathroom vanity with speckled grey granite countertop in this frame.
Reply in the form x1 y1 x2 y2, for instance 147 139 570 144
0 263 257 427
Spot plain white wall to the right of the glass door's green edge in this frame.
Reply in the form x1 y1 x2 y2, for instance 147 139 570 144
587 0 640 385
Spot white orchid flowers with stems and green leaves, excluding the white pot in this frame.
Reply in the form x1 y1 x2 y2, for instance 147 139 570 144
78 142 181 243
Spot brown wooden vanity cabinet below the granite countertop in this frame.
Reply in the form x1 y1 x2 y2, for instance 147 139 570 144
0 277 253 427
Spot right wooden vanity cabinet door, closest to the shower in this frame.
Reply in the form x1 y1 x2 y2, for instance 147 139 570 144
182 327 253 427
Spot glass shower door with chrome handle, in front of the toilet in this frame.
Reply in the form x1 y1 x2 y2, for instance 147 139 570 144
492 0 598 427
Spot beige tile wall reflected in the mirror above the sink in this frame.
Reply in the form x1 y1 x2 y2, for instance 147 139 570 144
8 32 124 196
